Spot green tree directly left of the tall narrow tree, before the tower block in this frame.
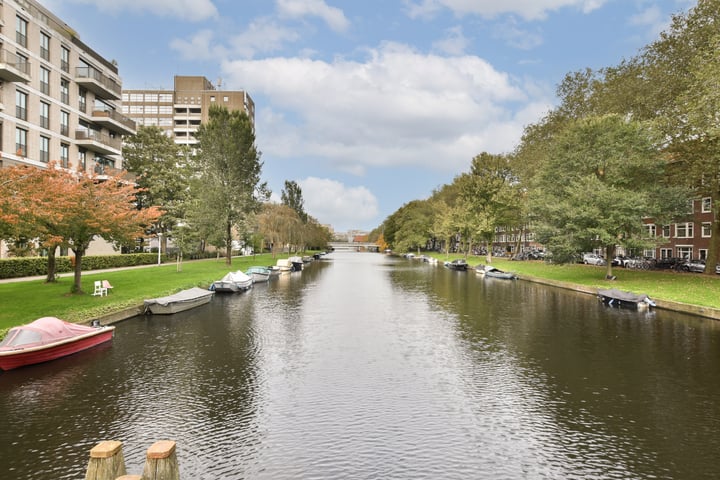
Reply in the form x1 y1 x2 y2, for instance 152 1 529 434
123 125 193 249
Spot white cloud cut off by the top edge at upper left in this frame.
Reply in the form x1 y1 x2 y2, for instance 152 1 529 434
52 0 218 22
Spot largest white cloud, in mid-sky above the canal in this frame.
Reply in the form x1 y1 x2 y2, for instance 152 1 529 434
223 44 553 175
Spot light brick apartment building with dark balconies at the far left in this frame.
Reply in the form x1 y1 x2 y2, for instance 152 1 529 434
0 0 136 174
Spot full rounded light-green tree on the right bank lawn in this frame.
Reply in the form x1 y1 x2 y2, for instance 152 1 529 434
531 115 687 277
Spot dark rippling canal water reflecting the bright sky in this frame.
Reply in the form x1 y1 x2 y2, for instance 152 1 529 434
0 252 720 480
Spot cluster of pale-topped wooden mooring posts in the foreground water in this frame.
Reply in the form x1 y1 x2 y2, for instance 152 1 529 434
85 440 180 480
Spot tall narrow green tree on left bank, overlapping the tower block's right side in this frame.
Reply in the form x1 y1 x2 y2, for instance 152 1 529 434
193 105 268 265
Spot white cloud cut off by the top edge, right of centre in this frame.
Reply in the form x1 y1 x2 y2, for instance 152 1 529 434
404 0 607 20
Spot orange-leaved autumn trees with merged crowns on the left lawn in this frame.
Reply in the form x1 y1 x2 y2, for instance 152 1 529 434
0 163 162 293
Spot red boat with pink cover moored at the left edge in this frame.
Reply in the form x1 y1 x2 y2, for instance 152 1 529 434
0 317 115 370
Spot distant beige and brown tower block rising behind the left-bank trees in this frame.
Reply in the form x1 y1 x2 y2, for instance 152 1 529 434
122 75 255 147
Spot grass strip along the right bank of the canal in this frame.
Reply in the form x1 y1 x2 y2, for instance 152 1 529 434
437 255 720 309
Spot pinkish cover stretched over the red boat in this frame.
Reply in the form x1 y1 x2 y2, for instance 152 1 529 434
0 317 97 351
